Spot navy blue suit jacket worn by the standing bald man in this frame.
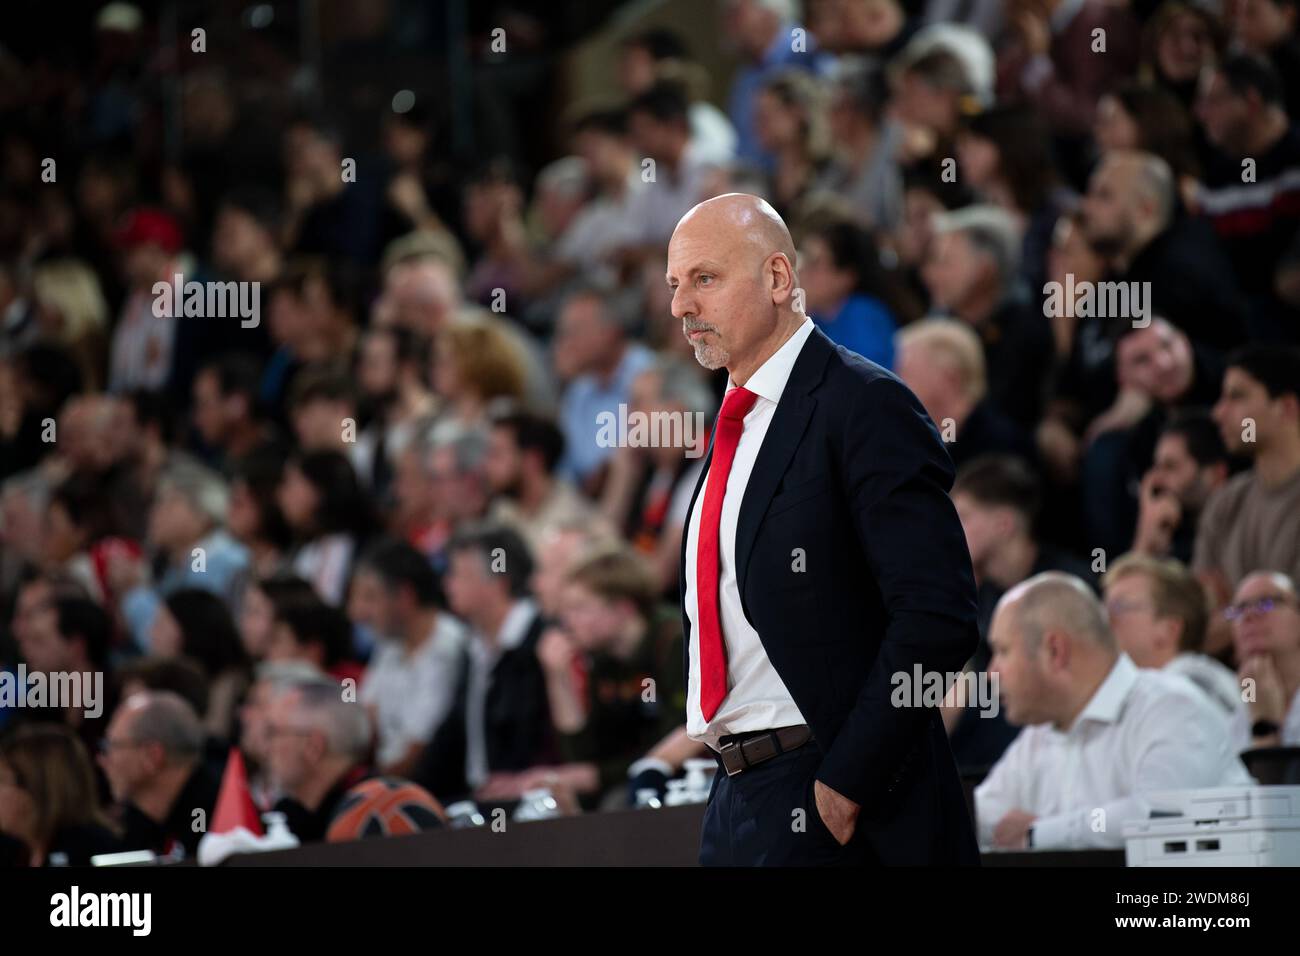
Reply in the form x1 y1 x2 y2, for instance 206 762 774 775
681 329 979 865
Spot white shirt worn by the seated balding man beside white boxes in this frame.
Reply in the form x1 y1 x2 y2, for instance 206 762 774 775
975 654 1255 849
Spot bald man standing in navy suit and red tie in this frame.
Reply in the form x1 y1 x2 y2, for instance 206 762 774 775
667 194 979 865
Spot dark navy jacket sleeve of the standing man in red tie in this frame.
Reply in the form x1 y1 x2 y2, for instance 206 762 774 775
818 378 979 814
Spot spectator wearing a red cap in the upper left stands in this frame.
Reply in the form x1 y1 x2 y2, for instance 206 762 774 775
108 207 182 392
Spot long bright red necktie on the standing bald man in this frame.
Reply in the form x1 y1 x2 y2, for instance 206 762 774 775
696 388 758 721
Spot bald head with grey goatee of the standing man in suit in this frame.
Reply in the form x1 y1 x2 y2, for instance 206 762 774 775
666 193 805 385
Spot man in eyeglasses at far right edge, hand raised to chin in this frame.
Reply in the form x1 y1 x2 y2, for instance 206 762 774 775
1223 571 1300 750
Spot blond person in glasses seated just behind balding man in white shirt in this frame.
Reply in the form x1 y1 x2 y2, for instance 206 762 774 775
1101 553 1242 717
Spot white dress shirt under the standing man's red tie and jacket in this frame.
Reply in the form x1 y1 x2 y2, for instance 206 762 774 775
685 319 813 750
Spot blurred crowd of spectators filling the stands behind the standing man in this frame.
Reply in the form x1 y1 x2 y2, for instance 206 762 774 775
0 0 1300 862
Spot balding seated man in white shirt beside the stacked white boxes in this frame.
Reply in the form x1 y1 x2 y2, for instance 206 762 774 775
975 572 1252 849
